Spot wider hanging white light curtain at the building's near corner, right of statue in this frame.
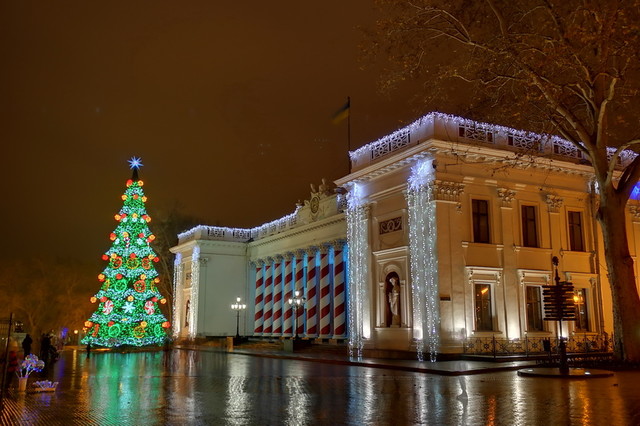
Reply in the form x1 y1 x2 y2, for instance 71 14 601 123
407 159 440 362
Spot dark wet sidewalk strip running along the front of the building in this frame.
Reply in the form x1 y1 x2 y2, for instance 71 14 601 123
174 345 536 376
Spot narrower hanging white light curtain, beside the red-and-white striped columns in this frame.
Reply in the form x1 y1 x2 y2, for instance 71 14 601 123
346 182 369 358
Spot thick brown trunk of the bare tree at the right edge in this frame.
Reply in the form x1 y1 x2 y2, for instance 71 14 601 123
598 194 640 362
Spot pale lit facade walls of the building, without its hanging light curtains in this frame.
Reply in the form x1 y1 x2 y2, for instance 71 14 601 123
172 114 640 358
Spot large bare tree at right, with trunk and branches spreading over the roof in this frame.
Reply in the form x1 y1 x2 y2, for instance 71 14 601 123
364 0 640 362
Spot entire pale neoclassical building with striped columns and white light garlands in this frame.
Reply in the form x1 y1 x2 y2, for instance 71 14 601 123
172 113 640 359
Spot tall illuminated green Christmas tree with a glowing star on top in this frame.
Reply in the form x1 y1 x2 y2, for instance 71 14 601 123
82 157 171 347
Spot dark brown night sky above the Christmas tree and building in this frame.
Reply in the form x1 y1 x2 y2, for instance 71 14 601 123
0 0 426 261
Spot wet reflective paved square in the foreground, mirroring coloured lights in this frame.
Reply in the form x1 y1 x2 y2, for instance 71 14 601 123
0 350 640 426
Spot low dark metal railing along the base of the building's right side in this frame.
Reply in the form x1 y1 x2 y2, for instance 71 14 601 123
463 335 612 356
